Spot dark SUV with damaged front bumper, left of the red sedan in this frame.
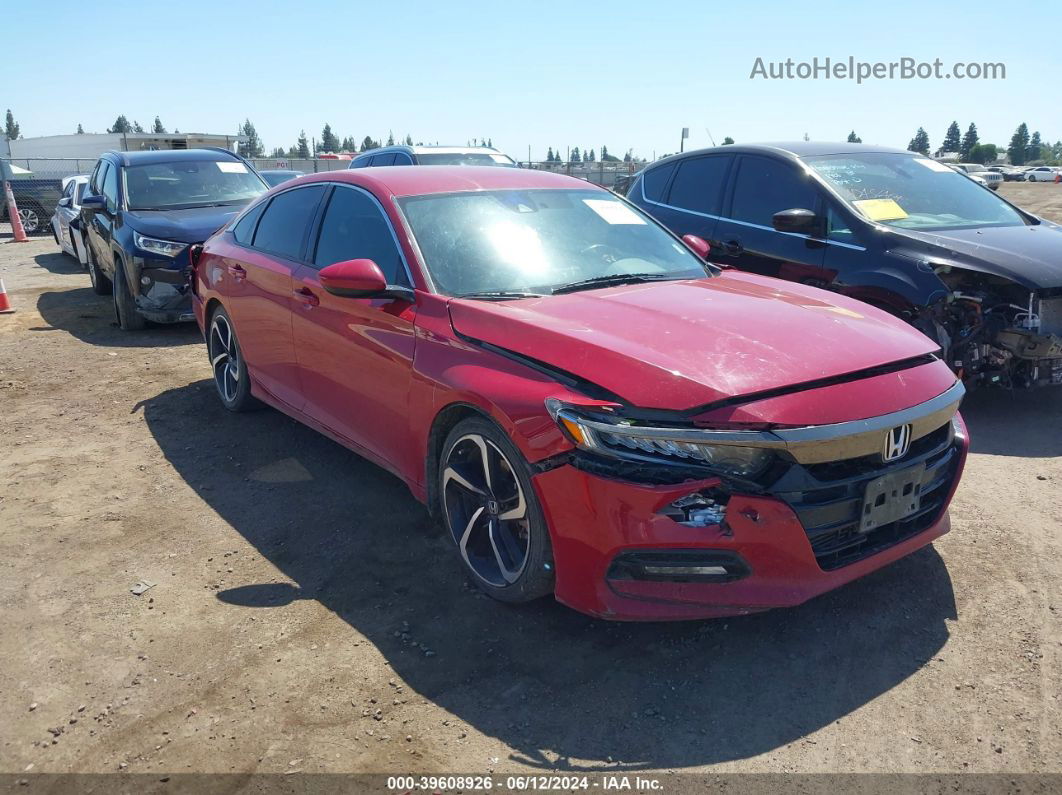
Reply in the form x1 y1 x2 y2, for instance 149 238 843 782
80 149 269 330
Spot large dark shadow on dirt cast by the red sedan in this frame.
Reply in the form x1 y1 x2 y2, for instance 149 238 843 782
140 380 956 770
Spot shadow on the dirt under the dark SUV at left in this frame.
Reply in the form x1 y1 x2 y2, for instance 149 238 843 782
30 286 200 346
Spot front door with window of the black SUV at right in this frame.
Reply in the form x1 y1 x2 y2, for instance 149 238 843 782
712 155 826 281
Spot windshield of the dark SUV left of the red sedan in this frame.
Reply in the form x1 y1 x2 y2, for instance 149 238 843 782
125 160 267 210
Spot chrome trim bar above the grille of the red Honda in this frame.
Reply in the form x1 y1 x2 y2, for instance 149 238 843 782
560 380 966 464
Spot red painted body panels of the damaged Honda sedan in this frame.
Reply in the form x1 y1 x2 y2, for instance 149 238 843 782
193 167 967 620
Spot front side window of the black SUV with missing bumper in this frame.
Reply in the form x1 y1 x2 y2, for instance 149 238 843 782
730 157 819 228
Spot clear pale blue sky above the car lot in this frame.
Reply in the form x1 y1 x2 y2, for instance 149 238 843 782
0 0 1062 159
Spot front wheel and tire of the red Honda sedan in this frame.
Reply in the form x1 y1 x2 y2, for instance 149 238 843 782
438 417 553 603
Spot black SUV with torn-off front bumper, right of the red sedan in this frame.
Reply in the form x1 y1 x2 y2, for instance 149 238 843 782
628 142 1062 387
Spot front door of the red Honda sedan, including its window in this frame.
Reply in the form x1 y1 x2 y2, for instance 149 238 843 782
292 185 416 466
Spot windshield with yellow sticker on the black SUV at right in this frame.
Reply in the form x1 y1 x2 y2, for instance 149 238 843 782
804 153 1026 229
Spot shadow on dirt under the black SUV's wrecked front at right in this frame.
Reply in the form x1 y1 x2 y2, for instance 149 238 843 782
961 386 1062 459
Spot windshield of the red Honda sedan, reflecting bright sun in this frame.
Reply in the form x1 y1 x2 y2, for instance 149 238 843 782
399 190 707 295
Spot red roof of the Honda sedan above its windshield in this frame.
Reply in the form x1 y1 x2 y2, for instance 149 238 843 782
285 166 607 196
